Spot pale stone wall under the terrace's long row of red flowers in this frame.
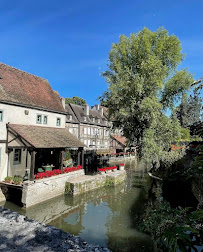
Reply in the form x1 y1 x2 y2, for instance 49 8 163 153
22 169 84 207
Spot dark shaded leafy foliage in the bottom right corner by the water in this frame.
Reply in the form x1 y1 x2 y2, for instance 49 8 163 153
139 202 203 252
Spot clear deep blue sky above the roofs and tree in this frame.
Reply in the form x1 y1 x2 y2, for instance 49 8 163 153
0 0 203 105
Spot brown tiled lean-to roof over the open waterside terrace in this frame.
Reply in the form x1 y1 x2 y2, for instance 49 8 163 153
8 124 85 148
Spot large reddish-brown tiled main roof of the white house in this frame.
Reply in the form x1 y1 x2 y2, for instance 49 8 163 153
0 63 65 113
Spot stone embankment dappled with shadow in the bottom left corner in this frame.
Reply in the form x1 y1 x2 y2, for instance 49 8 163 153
0 207 110 252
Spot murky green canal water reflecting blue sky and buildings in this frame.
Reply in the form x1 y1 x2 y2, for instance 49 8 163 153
2 160 157 252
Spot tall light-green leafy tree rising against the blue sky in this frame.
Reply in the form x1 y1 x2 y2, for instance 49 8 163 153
100 28 193 159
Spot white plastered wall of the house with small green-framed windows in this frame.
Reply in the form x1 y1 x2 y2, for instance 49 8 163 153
0 103 66 181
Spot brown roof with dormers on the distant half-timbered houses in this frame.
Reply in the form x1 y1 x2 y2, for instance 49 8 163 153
70 104 106 126
